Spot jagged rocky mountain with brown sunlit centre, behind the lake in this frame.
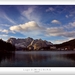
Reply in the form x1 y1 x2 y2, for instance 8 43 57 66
7 37 53 50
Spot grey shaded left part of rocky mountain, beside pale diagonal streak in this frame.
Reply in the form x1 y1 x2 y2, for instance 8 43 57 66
7 37 33 48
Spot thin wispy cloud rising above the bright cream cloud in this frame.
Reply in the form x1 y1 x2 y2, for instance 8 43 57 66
21 6 41 23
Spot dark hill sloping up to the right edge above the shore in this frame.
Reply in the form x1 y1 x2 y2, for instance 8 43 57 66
55 39 75 50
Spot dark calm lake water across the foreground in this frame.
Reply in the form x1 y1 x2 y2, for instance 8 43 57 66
0 51 75 67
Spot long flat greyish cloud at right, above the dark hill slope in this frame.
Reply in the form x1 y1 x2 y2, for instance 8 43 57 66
46 27 75 38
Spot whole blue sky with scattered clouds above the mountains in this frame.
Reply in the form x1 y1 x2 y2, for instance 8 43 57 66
0 5 75 44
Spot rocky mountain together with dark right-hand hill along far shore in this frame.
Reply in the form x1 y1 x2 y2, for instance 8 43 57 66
1 37 75 51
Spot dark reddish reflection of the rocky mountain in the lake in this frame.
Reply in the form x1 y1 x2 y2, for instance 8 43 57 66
15 54 51 67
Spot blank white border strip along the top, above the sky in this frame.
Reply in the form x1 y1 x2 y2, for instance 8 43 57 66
0 0 75 5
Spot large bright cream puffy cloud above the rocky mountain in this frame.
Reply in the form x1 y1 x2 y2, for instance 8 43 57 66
9 21 43 32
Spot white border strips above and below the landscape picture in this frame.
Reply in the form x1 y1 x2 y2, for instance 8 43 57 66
0 0 75 75
